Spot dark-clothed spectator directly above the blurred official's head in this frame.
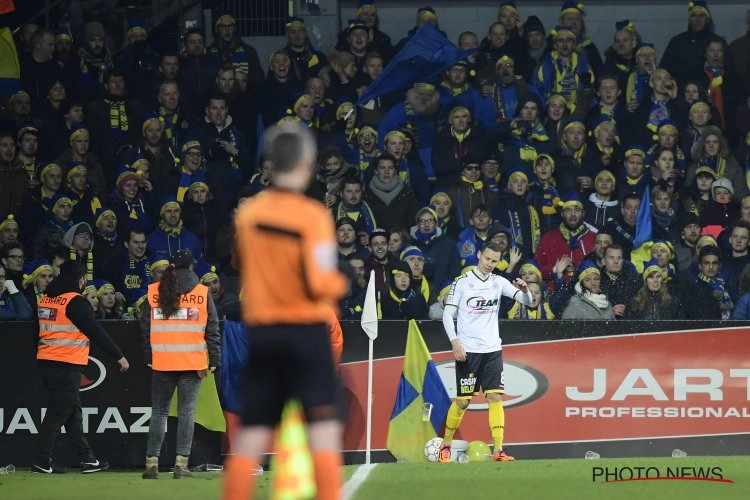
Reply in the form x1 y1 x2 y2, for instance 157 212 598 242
256 50 303 127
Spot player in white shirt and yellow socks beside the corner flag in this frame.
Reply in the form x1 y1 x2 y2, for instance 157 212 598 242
438 242 533 462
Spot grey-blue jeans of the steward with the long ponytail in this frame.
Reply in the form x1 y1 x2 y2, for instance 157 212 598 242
146 370 201 457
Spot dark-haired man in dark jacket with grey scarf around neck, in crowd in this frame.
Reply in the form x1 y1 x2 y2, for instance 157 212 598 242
365 153 420 231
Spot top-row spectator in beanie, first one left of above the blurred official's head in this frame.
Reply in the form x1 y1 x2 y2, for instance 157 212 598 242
208 14 263 87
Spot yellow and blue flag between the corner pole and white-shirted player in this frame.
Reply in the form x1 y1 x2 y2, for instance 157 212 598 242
386 320 451 462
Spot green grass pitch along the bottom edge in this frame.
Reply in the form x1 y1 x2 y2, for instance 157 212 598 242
0 457 750 500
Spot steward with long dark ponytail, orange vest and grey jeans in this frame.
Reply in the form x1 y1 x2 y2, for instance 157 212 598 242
141 249 221 479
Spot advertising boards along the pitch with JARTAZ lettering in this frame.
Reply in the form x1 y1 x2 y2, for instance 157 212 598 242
0 321 750 467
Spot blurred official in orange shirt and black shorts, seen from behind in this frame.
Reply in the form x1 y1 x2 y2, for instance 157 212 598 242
223 123 347 500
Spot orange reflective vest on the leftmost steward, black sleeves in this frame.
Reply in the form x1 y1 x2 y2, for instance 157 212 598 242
36 292 90 366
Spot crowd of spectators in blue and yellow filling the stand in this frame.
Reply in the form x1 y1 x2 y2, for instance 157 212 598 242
0 0 750 320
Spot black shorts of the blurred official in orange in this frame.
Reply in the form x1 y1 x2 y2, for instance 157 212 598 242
241 323 340 426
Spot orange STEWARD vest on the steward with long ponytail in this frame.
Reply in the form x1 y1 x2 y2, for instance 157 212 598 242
148 283 208 372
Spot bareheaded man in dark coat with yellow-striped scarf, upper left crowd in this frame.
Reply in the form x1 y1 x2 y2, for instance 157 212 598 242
88 70 143 169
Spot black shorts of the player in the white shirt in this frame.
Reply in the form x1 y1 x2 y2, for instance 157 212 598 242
456 351 505 399
